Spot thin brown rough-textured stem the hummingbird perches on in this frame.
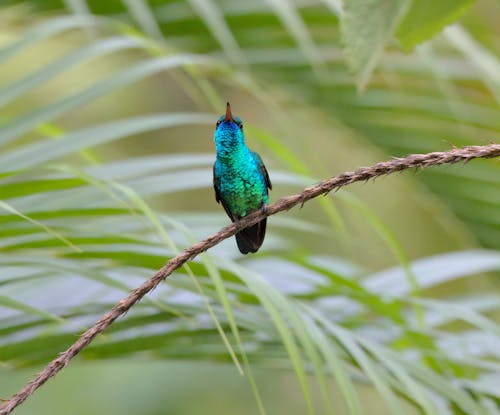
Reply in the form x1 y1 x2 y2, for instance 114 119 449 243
0 144 500 415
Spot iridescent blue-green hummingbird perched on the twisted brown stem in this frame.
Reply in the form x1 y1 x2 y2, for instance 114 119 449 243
213 102 272 254
